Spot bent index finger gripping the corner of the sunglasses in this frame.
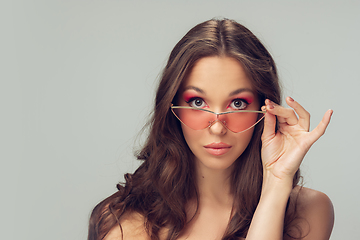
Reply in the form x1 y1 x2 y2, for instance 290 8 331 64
265 99 298 126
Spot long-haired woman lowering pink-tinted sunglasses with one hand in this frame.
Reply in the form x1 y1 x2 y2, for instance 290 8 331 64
88 19 333 240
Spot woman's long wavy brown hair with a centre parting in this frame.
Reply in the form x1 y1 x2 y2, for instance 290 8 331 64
88 19 299 240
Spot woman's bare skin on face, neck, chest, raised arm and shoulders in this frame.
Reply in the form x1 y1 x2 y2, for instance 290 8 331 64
105 57 334 240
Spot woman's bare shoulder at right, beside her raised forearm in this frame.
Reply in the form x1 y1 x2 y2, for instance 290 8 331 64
290 186 334 240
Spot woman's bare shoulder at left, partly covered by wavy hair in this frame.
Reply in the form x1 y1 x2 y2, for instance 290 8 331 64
104 212 150 240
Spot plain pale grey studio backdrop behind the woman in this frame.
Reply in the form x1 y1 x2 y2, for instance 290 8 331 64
0 0 360 240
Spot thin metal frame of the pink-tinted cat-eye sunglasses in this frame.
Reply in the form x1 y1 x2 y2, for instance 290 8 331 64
170 104 266 133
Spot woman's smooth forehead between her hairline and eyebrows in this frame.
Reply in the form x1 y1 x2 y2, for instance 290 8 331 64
182 56 253 94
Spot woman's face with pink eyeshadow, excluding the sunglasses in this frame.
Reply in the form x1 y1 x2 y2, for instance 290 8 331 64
177 56 260 170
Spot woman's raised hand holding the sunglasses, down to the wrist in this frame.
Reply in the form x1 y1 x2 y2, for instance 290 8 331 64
261 97 333 183
